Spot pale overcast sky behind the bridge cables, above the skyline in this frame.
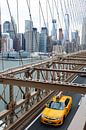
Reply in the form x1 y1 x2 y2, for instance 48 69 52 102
0 0 86 35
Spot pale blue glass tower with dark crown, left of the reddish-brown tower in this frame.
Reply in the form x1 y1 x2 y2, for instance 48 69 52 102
51 19 57 40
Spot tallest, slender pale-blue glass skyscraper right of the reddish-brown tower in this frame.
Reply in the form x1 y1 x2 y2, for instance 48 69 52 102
64 14 70 41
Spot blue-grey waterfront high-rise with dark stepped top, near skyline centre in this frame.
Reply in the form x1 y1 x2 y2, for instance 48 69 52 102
39 27 48 53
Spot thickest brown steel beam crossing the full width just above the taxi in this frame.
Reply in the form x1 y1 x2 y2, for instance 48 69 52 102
0 77 86 94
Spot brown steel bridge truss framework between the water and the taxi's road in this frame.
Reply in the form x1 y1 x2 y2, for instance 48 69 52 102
0 51 86 130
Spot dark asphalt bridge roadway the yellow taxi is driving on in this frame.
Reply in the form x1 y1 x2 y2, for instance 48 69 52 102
25 76 86 130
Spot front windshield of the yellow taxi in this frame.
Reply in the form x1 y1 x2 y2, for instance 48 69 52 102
48 102 64 110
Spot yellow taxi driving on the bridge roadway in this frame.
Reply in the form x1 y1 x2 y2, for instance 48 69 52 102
40 95 72 126
